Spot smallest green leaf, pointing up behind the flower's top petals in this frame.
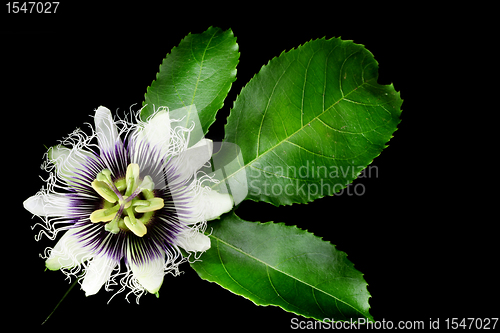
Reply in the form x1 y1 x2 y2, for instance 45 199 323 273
141 27 240 134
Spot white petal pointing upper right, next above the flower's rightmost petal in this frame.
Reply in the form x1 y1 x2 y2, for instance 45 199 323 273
172 139 213 181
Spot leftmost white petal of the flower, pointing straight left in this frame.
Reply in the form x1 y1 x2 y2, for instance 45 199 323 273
23 194 70 216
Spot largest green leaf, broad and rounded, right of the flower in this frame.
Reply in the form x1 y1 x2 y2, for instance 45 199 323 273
224 38 402 205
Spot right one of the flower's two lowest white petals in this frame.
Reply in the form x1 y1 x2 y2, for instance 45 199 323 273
129 251 165 294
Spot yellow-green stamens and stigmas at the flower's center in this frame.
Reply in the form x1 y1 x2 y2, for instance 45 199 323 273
90 163 164 237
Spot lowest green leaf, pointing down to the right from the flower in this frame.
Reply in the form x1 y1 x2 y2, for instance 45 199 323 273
191 212 373 321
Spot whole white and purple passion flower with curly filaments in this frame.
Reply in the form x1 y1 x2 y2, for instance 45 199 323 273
24 105 234 298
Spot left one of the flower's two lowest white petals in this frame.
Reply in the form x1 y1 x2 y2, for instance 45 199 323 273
82 255 118 296
